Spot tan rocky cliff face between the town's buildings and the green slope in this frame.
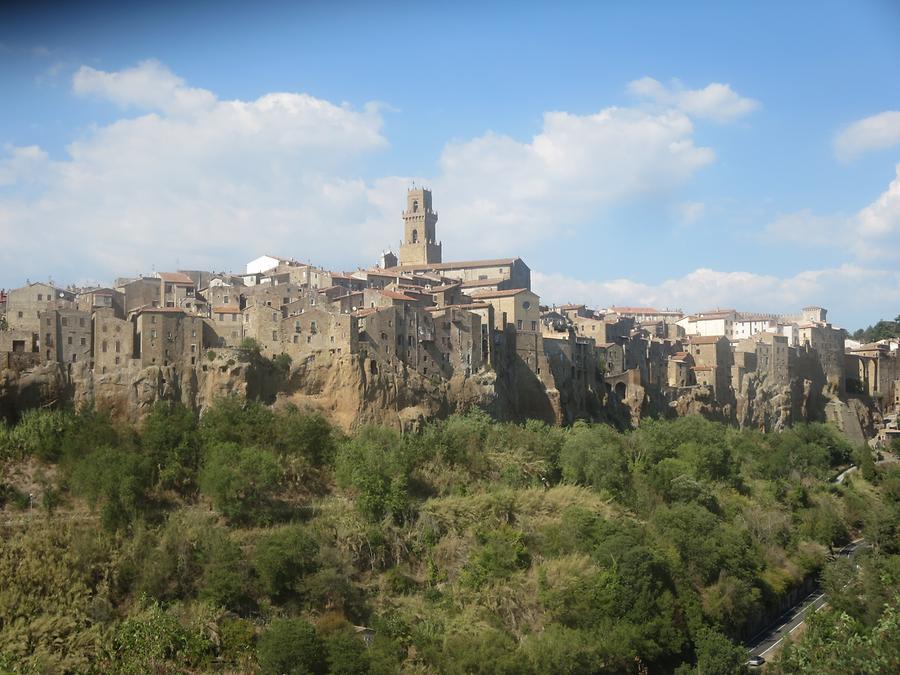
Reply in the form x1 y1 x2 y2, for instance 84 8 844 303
0 350 879 443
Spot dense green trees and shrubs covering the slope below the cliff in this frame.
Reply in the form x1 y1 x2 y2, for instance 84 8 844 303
0 399 900 674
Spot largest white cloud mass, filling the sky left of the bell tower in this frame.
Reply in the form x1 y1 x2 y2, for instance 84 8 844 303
0 62 398 283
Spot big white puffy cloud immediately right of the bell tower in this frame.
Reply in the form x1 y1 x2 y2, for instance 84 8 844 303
431 108 715 254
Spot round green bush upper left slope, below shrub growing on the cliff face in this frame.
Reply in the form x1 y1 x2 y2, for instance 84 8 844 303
200 443 281 523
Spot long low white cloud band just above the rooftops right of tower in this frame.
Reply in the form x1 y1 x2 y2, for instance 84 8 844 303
532 265 900 326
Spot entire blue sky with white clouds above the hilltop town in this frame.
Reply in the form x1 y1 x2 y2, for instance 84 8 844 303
0 1 900 328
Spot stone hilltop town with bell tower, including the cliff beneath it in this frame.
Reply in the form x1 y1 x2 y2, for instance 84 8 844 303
0 188 900 442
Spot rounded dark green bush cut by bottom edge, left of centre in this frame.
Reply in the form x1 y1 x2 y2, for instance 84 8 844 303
257 619 328 675
